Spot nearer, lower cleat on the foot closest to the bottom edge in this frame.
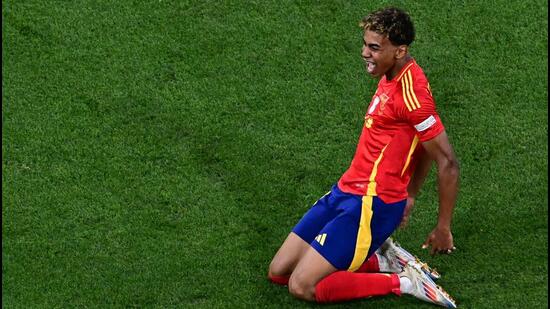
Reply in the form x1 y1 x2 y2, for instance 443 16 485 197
399 261 456 308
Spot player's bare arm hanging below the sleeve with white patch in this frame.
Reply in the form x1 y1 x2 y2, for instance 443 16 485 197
422 131 459 254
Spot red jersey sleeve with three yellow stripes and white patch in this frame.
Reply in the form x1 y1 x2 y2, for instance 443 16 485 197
401 76 445 142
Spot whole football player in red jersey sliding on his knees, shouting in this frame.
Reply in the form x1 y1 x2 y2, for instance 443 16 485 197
268 7 459 308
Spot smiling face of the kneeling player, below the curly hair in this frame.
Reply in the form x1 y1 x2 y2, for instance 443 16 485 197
361 30 404 78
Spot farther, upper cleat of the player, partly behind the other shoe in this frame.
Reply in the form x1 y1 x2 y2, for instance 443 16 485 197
378 237 441 280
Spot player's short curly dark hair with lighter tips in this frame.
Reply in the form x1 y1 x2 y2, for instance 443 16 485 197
359 7 415 45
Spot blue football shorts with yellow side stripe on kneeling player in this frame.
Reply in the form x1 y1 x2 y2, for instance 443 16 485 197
292 185 406 271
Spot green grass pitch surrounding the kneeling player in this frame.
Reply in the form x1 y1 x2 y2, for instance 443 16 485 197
2 0 548 308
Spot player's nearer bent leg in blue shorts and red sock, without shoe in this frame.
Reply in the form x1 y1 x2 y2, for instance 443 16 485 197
289 197 408 302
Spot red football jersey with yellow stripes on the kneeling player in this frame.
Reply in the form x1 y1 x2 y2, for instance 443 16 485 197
338 60 445 203
